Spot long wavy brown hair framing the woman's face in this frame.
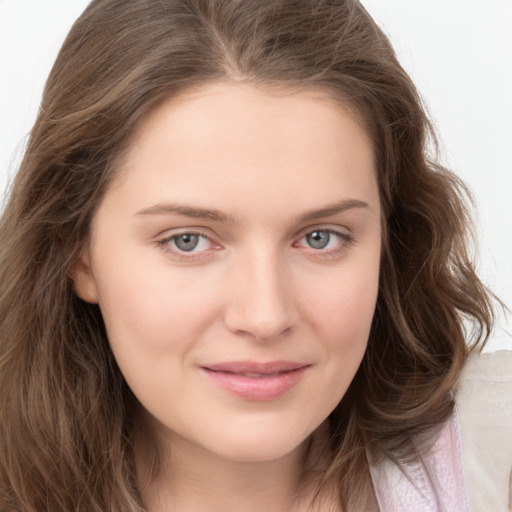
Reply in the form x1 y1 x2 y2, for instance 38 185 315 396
0 0 493 512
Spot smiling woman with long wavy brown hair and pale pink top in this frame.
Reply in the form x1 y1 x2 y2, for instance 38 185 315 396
0 0 510 512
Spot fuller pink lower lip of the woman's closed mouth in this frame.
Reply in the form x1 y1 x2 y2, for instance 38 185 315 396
202 366 307 401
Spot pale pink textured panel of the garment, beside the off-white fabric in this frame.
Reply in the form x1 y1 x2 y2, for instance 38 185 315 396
368 410 471 512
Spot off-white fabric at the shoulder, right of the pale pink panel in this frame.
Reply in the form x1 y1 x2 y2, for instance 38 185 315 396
456 350 512 512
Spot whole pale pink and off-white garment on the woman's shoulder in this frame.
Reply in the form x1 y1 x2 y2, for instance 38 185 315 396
368 351 512 512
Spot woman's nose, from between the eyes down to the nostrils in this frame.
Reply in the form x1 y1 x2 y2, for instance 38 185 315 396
225 246 298 341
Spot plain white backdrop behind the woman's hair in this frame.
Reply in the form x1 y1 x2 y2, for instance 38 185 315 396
0 0 512 350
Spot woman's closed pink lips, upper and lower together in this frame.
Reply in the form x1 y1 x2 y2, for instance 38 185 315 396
201 361 309 401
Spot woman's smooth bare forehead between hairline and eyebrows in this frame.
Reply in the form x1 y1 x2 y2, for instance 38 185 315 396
104 83 376 220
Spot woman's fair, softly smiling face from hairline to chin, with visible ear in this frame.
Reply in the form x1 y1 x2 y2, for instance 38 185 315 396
75 84 381 461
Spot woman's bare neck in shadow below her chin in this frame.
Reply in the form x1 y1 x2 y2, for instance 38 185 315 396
135 422 334 512
